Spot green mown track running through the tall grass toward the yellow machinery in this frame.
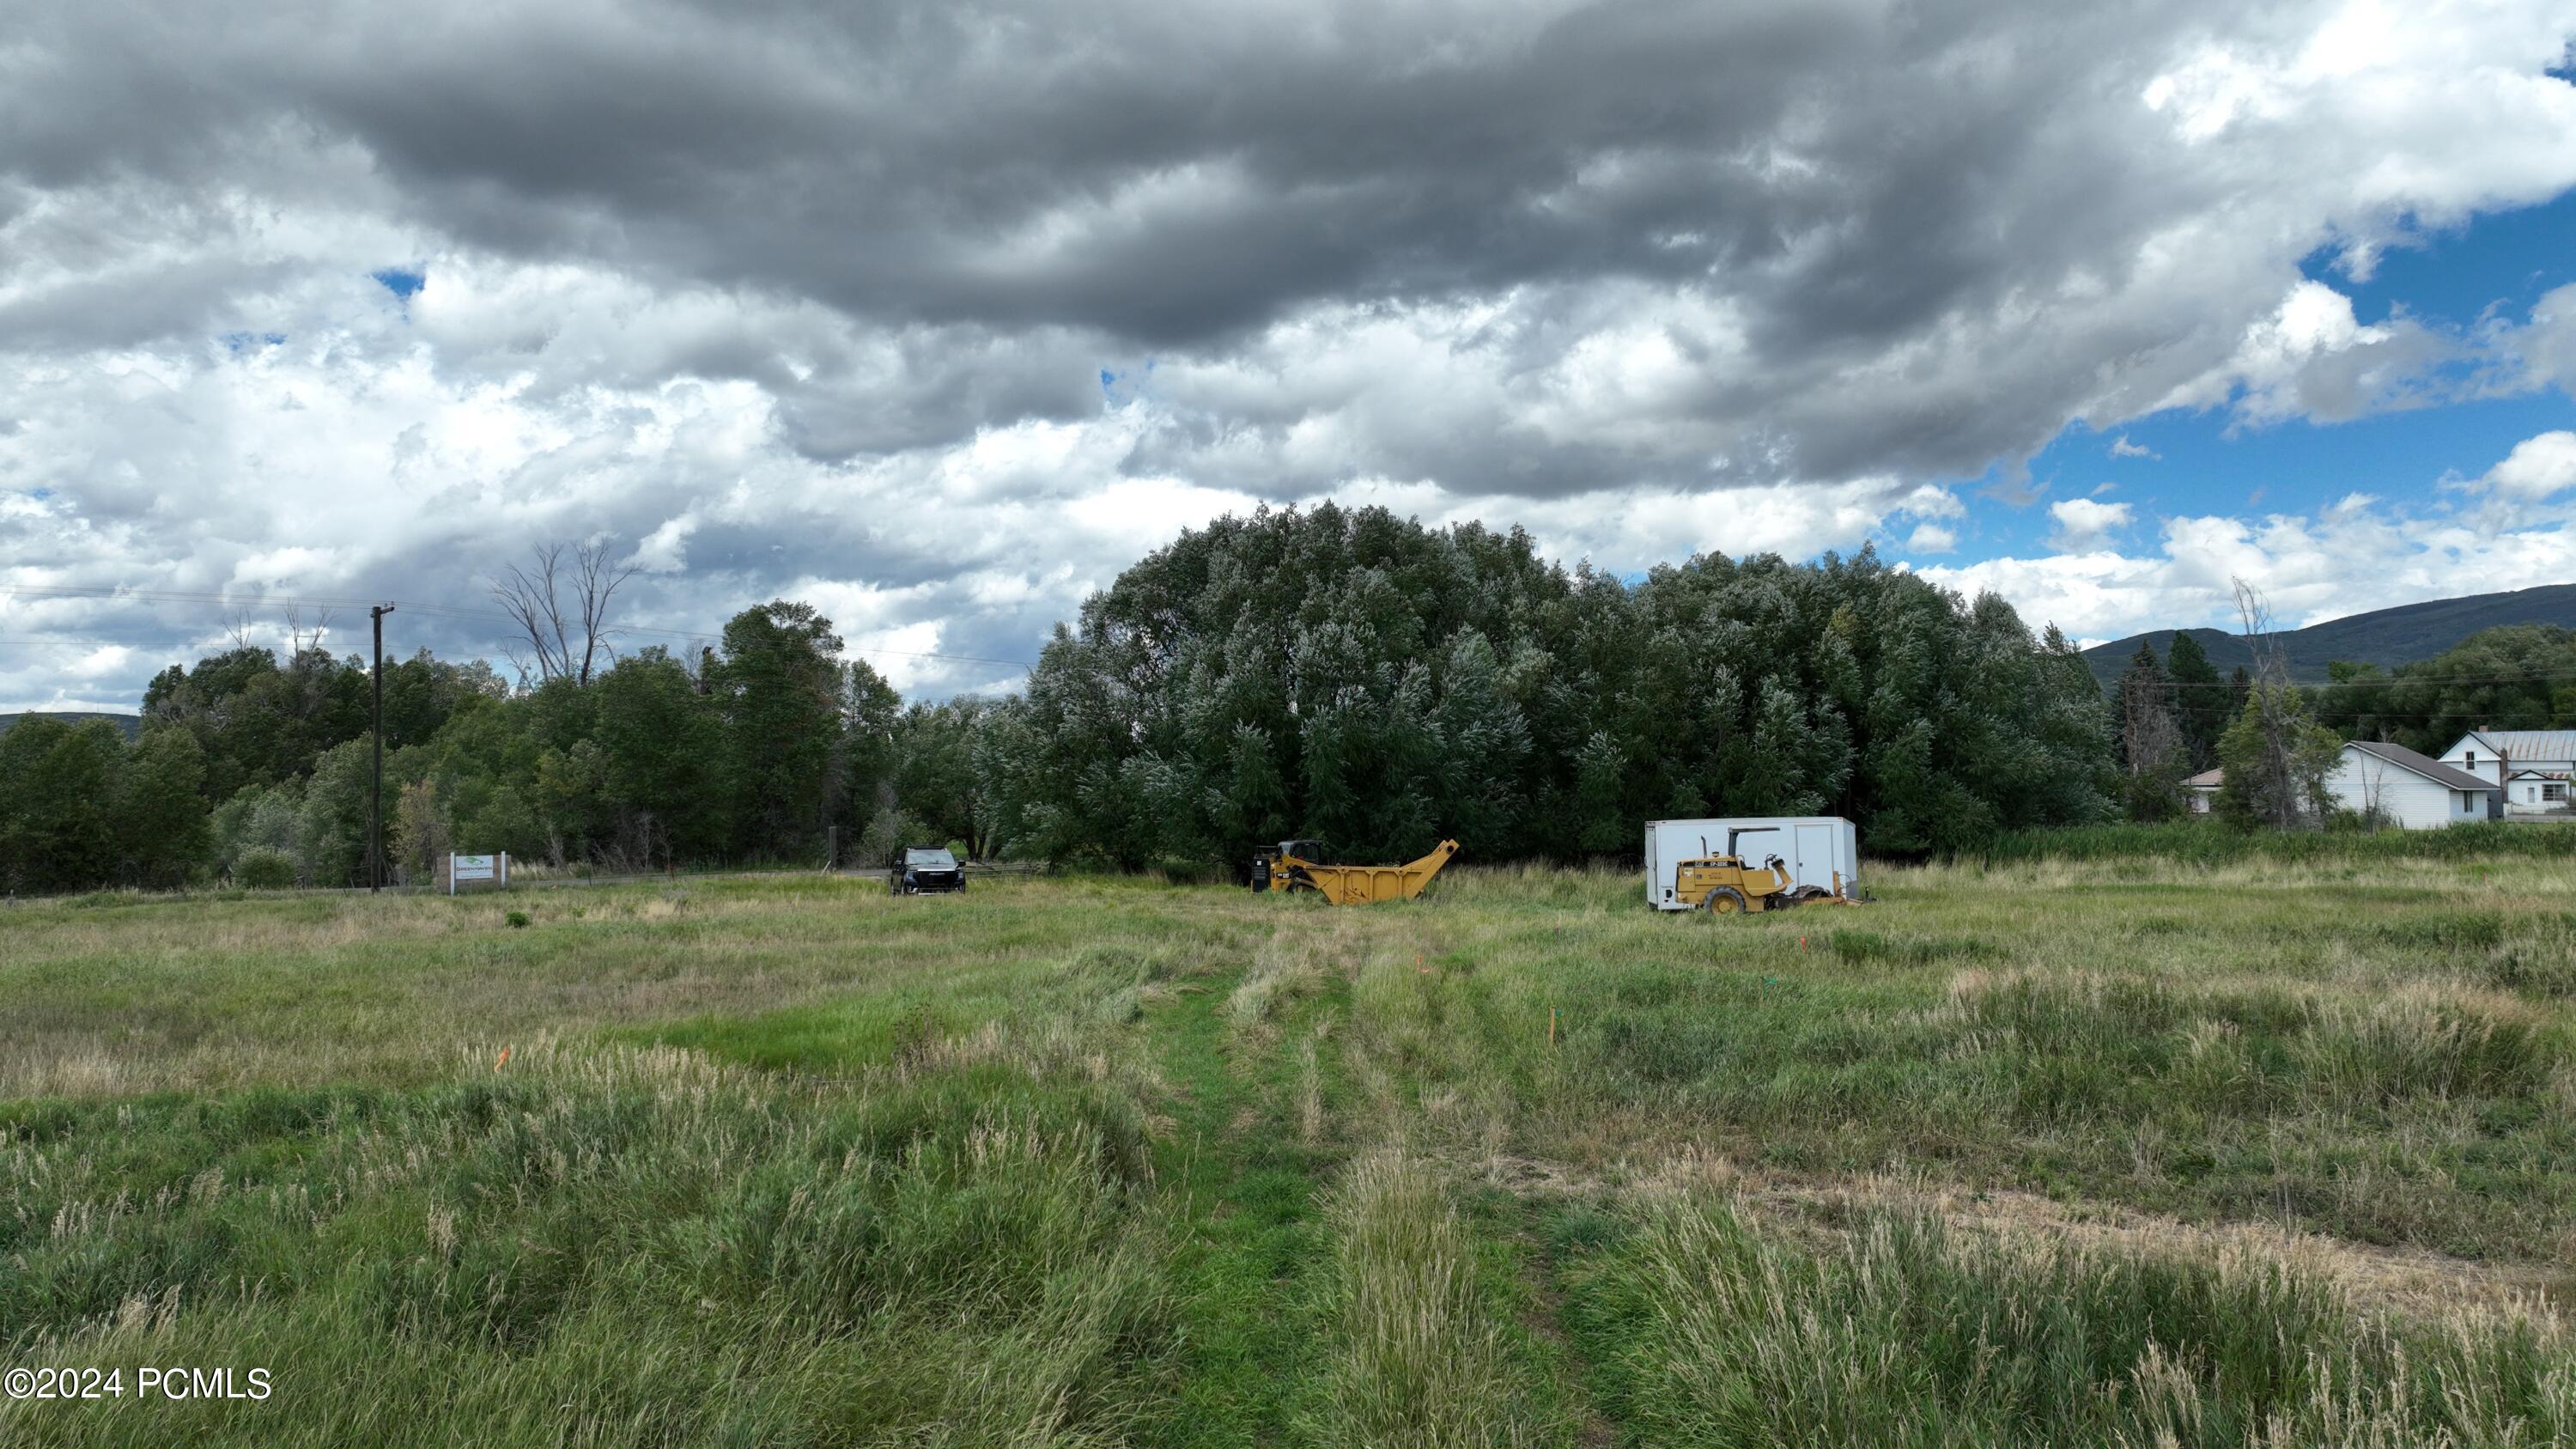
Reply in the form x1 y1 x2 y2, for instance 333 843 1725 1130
1136 943 1613 1446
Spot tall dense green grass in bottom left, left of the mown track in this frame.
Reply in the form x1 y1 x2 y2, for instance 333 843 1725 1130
0 1052 1170 1444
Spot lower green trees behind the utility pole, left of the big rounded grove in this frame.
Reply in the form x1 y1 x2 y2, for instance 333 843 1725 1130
0 600 912 890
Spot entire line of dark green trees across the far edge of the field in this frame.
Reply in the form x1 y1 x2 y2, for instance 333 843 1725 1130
60 505 2576 890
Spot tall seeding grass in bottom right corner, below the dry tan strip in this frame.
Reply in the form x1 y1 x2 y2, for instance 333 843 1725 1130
1574 1202 2576 1449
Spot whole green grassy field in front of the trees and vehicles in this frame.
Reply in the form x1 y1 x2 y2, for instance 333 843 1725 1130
0 859 2576 1446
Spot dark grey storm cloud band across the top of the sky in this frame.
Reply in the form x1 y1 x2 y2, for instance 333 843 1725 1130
10 5 2236 348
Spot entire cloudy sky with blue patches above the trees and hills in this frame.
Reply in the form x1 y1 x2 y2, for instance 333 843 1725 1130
0 0 2576 709
